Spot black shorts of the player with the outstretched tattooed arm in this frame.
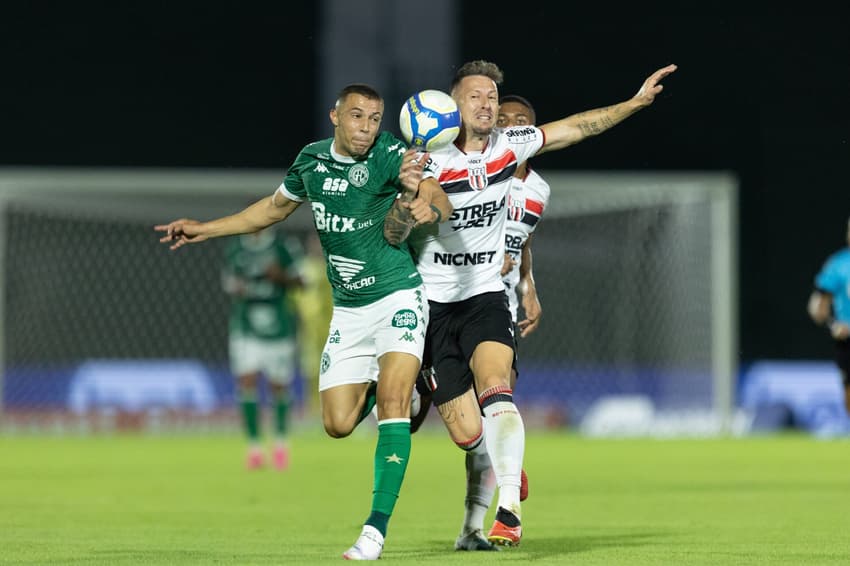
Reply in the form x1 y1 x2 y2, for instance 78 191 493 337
425 291 516 405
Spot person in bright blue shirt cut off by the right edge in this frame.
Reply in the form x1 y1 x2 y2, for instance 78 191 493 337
808 220 850 413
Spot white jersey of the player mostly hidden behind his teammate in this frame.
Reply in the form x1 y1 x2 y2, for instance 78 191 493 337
502 168 550 322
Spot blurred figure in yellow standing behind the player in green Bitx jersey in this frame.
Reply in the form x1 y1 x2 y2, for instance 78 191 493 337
292 232 333 417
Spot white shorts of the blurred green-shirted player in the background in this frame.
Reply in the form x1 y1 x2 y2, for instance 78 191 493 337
230 334 297 385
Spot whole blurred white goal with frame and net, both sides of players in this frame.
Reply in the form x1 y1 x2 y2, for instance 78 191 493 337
0 169 737 433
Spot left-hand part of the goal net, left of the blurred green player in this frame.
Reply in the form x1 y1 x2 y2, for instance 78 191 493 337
0 169 311 430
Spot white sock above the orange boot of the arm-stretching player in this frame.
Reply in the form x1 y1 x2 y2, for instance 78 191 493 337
483 400 525 517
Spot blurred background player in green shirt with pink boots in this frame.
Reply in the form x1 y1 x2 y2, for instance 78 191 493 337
222 229 302 470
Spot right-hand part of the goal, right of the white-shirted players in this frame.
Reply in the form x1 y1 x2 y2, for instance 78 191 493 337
515 173 737 434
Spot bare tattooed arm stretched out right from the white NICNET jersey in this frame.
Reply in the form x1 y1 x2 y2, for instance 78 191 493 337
537 65 676 154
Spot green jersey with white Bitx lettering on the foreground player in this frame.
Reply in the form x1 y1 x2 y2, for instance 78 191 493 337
278 132 422 307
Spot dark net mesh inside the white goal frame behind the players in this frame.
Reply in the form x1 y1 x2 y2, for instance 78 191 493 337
2 172 728 434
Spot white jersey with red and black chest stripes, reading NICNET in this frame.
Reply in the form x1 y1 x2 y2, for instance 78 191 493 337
410 126 545 303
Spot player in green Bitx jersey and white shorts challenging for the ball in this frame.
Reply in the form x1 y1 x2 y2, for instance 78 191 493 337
154 84 452 560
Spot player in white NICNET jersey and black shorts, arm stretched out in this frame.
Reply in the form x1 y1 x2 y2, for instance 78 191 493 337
410 61 676 550
